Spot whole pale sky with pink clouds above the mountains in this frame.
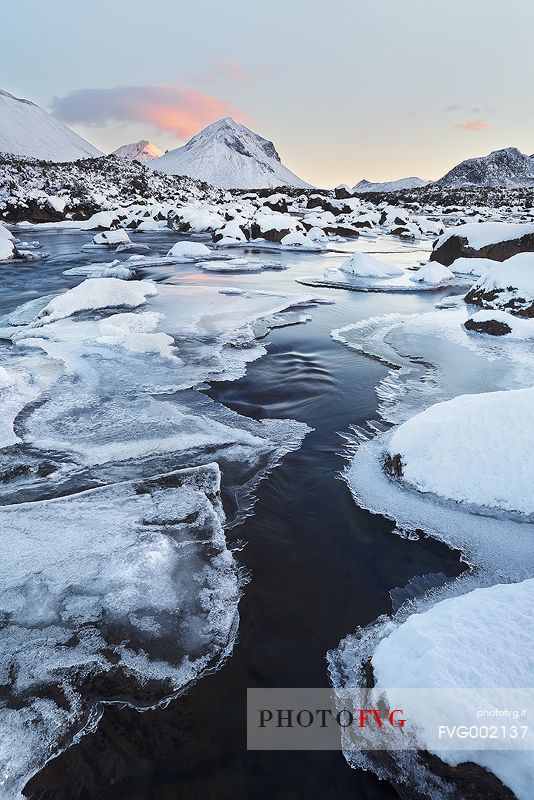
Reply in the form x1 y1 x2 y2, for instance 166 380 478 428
0 0 534 186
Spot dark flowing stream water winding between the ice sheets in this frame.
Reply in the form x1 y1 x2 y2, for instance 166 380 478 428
4 228 466 800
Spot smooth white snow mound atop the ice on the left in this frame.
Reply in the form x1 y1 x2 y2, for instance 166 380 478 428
33 278 158 326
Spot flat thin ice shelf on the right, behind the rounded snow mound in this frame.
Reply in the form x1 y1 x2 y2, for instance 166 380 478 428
332 303 532 424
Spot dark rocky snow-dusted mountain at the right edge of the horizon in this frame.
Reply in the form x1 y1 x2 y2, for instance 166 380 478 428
437 147 534 189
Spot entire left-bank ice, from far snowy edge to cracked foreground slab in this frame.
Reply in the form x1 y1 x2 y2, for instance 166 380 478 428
0 278 326 800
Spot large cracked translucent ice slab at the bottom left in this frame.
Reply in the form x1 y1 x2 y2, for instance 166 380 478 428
0 464 240 800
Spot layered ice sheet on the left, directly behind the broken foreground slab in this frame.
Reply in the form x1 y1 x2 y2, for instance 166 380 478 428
0 279 312 500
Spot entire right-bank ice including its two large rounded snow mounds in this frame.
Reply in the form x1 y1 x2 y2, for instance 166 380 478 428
328 303 534 800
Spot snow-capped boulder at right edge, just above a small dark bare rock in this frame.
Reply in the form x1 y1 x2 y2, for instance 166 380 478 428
465 253 534 317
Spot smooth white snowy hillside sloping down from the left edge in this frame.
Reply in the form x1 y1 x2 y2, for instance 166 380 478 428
0 89 102 161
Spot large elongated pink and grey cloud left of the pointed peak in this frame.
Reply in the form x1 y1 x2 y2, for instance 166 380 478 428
52 86 241 139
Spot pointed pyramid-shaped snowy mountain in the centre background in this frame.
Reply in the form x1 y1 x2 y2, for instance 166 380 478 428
151 117 313 189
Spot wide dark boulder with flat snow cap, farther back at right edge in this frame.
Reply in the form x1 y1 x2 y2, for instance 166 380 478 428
430 222 534 267
